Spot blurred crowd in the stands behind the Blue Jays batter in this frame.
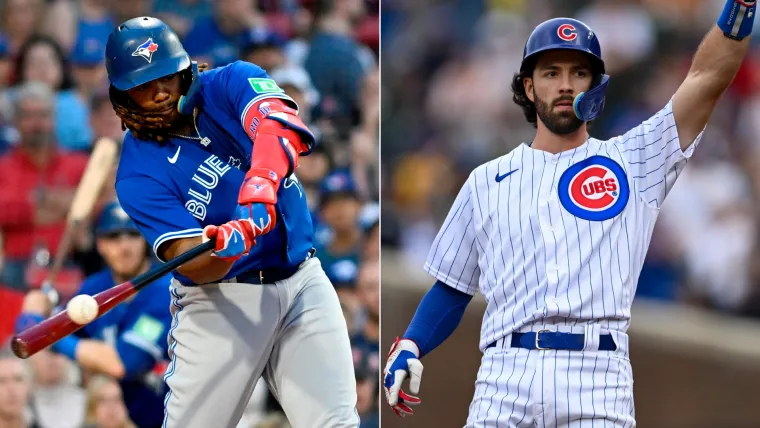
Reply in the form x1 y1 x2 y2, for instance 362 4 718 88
0 0 380 428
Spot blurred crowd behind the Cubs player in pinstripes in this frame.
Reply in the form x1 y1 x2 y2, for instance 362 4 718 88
381 0 760 317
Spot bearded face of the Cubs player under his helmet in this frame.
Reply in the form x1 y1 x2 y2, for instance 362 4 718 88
524 51 593 135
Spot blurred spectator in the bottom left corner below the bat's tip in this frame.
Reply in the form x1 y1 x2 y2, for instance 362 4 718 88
0 348 37 428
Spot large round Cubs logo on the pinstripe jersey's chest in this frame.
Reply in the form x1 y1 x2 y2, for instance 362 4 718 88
557 156 630 221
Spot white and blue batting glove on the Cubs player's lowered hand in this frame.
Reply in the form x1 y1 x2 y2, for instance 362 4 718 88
383 337 422 418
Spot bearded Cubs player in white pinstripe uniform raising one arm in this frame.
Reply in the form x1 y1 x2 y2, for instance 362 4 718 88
384 0 756 428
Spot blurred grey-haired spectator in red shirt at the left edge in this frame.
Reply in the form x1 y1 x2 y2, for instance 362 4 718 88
0 82 87 291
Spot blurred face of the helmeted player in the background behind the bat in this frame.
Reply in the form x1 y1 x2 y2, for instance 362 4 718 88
97 232 147 277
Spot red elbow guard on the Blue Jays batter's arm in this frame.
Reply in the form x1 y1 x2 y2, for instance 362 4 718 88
243 99 315 179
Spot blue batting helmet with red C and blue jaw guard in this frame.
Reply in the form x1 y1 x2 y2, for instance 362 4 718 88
520 18 610 122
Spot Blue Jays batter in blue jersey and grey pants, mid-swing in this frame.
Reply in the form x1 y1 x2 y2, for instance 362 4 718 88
106 17 359 428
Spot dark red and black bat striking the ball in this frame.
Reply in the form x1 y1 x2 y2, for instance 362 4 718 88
11 239 216 358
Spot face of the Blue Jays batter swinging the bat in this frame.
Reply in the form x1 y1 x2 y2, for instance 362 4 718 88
127 73 182 123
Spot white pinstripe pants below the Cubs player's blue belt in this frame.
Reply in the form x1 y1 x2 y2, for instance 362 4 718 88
466 347 636 428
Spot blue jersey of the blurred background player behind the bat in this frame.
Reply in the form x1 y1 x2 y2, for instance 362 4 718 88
72 269 172 427
